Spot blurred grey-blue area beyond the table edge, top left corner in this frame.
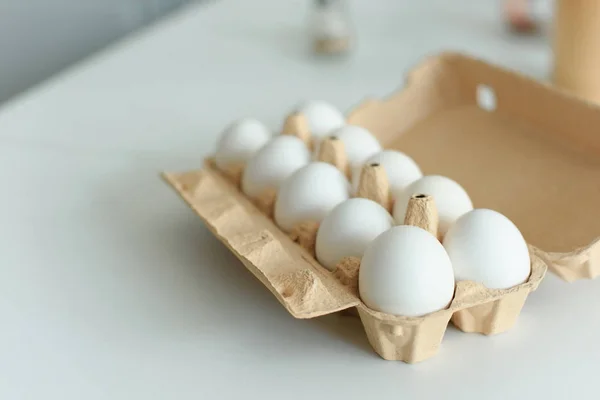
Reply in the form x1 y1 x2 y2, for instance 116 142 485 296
0 0 193 103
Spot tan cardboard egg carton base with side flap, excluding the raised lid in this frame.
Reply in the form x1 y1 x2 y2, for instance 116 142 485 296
165 159 546 363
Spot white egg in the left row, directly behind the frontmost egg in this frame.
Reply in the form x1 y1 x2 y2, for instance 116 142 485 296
315 198 394 270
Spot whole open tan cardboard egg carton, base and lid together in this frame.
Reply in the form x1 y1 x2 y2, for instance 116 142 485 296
164 50 600 362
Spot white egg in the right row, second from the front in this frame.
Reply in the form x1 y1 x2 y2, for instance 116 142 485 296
394 175 473 236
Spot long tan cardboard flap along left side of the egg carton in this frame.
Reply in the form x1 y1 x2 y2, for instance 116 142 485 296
164 160 359 318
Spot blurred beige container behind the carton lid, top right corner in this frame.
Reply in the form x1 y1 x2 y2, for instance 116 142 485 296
553 0 600 102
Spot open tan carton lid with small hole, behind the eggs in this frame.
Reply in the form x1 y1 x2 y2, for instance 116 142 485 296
348 54 600 281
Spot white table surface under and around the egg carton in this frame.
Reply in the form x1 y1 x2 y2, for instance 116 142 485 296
0 0 600 400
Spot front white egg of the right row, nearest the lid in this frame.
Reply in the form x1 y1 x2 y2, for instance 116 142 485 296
444 209 531 289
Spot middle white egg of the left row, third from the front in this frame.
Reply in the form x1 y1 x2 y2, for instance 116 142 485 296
275 162 350 232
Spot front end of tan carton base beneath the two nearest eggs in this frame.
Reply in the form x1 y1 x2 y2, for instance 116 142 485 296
357 249 546 363
